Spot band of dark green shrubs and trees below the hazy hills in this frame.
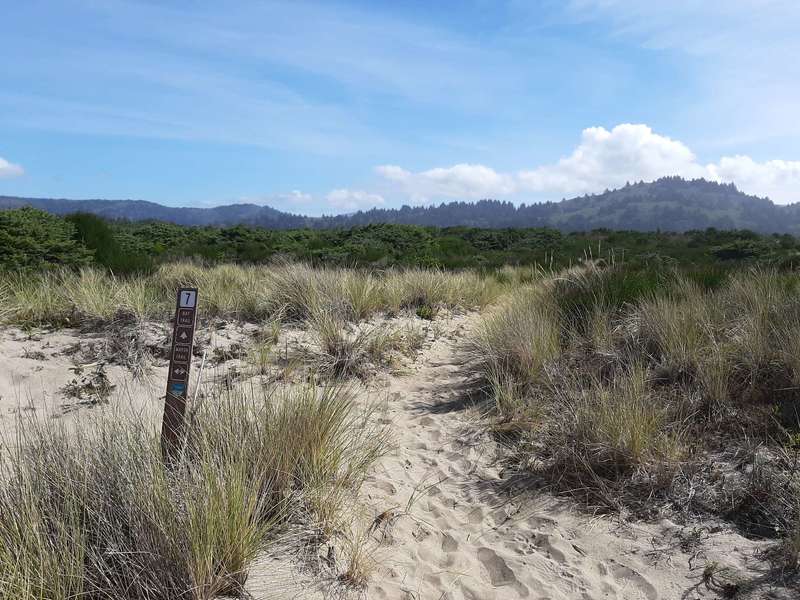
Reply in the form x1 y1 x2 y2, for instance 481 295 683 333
0 207 800 274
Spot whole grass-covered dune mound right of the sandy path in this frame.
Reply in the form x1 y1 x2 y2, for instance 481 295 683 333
470 265 800 556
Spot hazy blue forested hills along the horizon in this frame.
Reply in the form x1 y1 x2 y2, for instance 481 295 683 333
0 177 800 234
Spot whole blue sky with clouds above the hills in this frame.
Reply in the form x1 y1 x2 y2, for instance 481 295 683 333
0 0 800 214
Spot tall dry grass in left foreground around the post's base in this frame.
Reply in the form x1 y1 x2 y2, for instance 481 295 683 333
0 386 384 600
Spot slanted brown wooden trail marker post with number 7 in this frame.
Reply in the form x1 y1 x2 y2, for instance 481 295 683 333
161 288 197 465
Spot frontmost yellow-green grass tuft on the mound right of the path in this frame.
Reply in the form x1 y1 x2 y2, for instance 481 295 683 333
539 365 691 513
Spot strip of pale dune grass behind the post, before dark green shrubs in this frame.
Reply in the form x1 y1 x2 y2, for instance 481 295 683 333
0 262 499 326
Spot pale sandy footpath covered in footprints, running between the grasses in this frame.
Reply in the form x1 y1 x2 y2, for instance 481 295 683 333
352 315 776 600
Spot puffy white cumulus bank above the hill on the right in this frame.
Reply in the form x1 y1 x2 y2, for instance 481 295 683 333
376 123 800 203
